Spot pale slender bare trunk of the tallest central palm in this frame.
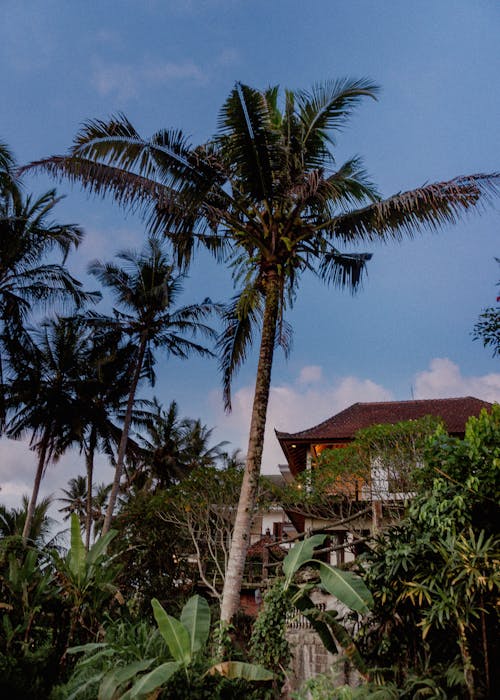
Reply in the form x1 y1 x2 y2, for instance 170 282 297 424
221 271 280 623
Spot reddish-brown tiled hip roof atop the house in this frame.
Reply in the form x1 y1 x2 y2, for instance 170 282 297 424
276 396 492 440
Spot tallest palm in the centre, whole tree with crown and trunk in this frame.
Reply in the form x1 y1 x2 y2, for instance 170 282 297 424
28 79 499 620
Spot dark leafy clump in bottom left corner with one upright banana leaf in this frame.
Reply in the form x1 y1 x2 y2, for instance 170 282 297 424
0 514 119 698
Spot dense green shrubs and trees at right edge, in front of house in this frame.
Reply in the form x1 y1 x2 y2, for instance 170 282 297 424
352 406 500 698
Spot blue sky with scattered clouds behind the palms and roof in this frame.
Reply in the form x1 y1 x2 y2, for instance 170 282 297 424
0 0 500 504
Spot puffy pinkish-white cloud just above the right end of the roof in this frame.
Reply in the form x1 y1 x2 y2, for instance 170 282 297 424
415 357 500 402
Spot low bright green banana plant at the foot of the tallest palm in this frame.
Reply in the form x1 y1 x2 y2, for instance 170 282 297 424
76 595 273 700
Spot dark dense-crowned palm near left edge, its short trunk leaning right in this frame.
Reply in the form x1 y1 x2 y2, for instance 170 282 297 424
5 318 91 543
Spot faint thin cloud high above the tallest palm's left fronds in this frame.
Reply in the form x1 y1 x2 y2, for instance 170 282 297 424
92 60 206 101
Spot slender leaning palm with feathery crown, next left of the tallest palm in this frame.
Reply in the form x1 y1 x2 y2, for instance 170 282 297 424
89 237 217 534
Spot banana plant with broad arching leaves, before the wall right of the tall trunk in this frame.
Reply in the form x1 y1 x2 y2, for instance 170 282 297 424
283 535 373 675
